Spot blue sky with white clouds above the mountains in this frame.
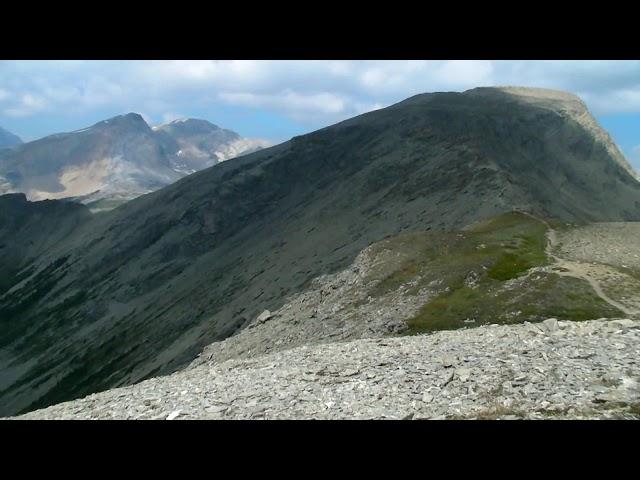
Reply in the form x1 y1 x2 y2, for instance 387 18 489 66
0 60 640 169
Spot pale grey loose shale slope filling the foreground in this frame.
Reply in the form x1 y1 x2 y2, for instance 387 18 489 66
18 319 640 420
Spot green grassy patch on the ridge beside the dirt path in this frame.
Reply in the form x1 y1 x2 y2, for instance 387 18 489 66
369 212 621 334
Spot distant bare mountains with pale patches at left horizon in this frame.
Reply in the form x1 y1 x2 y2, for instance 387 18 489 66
0 112 268 210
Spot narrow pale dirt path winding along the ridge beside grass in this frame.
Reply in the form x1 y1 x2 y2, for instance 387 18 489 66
522 212 640 316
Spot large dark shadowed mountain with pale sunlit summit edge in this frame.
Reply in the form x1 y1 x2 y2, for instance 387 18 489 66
0 89 640 414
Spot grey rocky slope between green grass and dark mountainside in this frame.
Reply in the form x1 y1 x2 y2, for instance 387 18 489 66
192 247 435 366
